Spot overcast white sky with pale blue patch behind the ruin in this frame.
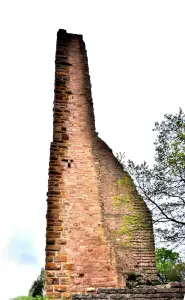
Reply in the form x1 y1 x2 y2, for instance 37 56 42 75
0 0 185 300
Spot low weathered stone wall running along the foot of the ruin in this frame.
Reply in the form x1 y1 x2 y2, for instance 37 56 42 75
72 282 185 300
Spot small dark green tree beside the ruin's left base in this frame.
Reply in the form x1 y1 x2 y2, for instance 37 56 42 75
29 268 45 297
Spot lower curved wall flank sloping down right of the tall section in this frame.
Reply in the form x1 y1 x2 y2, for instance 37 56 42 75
96 138 156 284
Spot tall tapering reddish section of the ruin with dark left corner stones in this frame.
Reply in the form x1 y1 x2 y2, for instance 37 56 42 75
46 32 117 298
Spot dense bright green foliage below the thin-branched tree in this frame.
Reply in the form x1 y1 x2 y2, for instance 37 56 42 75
156 248 185 283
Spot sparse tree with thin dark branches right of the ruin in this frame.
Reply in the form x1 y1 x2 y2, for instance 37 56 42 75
118 108 185 246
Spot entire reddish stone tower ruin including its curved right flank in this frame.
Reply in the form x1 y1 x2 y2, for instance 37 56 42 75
46 30 156 299
